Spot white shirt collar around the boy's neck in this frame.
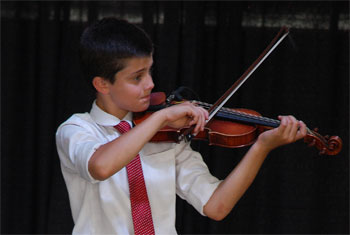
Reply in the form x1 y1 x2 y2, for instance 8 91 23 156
90 100 132 126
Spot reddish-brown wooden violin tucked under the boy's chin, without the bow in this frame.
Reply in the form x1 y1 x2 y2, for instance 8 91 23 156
133 92 342 155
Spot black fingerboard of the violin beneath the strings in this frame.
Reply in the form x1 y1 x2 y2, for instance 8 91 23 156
195 101 280 128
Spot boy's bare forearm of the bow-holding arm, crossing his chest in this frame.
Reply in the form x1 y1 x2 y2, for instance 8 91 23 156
89 112 166 180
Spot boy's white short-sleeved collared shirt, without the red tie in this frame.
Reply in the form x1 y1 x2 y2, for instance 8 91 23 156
56 102 220 234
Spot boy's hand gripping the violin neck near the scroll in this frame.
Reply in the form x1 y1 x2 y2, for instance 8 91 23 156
257 116 307 151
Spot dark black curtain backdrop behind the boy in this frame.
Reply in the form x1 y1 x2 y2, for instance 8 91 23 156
1 1 349 234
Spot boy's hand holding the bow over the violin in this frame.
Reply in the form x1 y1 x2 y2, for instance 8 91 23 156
160 101 209 134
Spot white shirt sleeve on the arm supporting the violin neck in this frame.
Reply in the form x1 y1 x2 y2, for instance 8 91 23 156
175 140 221 216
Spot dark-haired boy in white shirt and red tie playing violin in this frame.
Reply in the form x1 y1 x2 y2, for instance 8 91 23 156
56 18 306 234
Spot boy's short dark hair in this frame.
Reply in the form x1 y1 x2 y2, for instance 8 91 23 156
79 18 153 87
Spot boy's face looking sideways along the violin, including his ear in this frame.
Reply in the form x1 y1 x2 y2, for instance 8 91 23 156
109 56 154 118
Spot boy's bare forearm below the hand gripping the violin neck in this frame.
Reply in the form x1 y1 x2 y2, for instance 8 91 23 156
204 143 269 220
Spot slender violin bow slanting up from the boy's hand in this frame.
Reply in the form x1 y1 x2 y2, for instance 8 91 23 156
179 26 289 141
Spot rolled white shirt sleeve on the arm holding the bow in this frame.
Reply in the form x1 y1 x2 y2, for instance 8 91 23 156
56 121 104 183
